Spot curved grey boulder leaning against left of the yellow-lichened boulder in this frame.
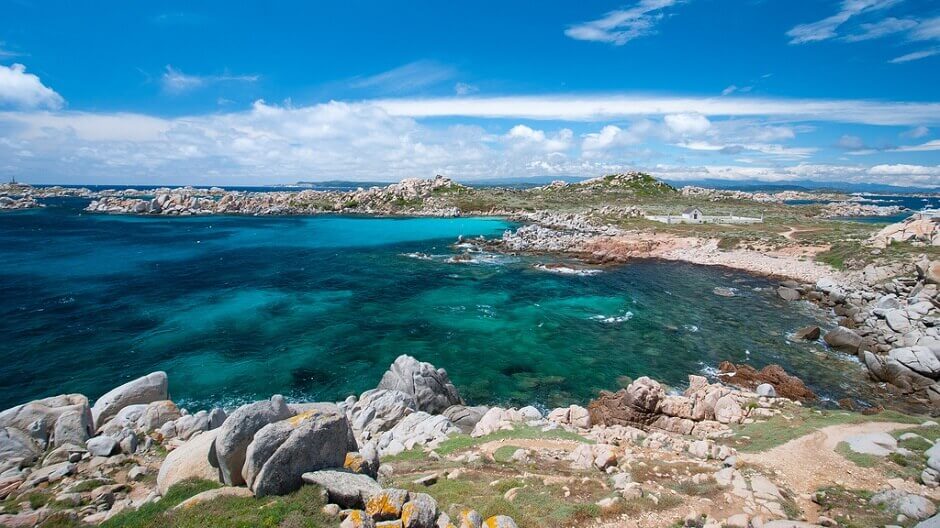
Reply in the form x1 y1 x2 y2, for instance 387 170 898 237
209 394 292 486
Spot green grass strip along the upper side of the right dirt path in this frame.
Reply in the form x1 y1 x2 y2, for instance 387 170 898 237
727 407 924 453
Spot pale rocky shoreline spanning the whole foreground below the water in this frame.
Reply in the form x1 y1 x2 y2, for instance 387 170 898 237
0 354 940 528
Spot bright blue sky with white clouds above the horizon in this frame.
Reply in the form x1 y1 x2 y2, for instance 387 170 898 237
0 0 940 186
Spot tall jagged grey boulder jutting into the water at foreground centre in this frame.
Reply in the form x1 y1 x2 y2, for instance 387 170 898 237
377 354 463 414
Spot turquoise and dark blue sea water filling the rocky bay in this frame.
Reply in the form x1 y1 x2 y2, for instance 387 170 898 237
0 200 868 408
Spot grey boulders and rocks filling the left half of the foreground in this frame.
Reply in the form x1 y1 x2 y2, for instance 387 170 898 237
0 356 515 528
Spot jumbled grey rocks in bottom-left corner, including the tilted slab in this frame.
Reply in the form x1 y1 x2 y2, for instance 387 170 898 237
0 372 225 526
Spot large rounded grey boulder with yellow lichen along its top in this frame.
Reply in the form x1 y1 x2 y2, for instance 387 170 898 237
242 410 349 497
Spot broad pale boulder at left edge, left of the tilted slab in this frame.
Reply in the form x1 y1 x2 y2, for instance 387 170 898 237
0 394 94 443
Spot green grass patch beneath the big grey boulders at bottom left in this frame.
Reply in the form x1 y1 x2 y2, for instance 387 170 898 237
101 480 336 528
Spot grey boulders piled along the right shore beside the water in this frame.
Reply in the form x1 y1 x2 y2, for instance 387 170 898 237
777 259 940 414
